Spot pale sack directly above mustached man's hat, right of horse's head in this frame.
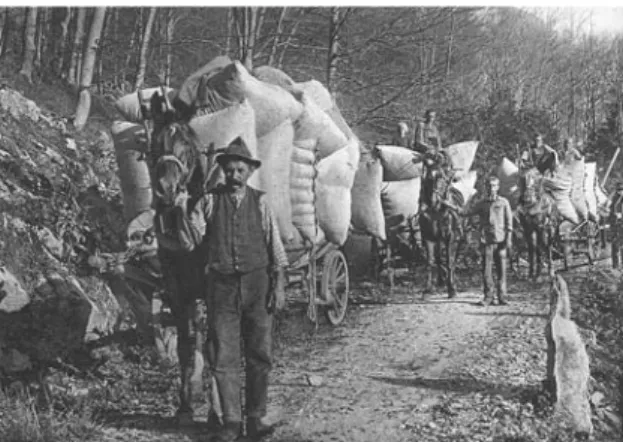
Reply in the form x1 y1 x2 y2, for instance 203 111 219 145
189 100 258 190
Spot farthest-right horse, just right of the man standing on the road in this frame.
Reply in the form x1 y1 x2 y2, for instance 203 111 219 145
517 167 560 280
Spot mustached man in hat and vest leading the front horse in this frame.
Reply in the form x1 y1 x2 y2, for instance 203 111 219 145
182 137 288 442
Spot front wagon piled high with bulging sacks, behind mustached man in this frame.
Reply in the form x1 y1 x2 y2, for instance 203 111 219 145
94 57 372 342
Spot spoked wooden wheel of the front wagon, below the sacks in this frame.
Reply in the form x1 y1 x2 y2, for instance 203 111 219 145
320 250 349 325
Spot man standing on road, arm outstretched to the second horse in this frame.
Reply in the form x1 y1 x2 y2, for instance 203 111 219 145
444 175 513 306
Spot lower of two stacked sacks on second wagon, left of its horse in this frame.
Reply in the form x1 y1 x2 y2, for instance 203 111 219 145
381 178 422 219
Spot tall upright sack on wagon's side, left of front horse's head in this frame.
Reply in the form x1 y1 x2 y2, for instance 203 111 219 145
111 121 152 222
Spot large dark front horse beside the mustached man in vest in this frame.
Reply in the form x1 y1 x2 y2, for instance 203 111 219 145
152 122 218 422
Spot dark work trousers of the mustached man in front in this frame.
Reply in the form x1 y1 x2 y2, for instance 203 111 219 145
207 268 273 423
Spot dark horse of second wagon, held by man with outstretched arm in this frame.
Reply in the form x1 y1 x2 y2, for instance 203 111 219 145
419 153 465 298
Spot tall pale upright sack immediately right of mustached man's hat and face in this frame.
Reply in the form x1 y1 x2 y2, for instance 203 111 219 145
249 120 294 243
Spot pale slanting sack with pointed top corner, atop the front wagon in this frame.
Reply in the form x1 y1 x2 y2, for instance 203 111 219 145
235 61 303 138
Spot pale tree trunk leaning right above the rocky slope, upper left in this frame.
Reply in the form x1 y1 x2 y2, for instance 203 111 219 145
74 8 106 130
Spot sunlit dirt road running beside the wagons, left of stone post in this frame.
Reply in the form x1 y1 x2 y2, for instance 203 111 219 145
270 272 547 442
